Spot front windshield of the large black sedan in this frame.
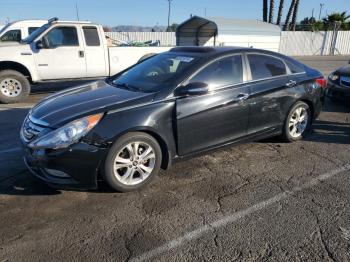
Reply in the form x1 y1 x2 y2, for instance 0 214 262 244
112 53 198 92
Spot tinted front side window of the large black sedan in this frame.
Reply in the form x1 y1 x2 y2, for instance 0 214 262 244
189 55 243 88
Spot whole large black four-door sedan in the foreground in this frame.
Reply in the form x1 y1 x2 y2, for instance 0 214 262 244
20 47 326 191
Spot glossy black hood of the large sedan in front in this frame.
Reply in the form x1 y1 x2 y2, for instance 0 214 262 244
30 80 154 128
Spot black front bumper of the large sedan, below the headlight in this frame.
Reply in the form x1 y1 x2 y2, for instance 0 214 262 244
23 142 107 189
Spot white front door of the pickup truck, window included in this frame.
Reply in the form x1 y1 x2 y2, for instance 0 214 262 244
34 25 86 80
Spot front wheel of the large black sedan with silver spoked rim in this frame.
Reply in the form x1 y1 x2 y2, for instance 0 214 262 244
103 132 162 192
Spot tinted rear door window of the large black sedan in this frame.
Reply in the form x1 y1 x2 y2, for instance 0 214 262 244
248 54 287 80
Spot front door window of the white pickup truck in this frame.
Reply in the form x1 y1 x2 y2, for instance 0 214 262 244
45 26 79 48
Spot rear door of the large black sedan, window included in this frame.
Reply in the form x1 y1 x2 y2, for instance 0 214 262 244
246 53 294 135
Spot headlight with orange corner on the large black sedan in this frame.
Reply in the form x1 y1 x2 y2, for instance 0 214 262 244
29 114 103 149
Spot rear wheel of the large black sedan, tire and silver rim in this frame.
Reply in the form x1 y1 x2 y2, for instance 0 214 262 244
282 101 312 142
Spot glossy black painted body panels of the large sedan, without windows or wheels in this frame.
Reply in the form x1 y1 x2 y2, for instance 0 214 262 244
23 48 322 189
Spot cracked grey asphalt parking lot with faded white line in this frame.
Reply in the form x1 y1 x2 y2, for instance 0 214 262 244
0 55 350 262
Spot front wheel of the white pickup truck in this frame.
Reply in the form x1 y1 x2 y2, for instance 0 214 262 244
0 70 30 104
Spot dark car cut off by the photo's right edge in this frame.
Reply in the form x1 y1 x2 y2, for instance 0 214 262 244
327 65 350 99
